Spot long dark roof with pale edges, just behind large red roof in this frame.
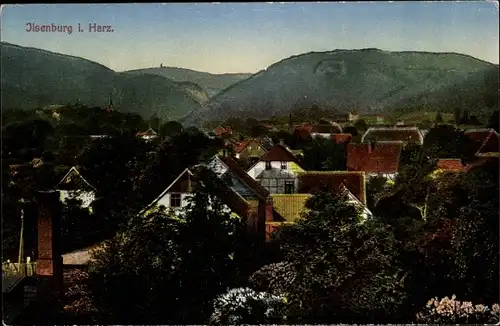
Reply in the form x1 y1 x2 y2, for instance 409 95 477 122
361 127 424 145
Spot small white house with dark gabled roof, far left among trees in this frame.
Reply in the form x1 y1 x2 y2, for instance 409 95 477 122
55 166 96 210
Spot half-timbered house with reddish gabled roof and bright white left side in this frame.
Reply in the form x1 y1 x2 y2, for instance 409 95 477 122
247 144 304 194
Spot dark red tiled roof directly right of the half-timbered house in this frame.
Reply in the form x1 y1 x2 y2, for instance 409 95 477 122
298 171 366 204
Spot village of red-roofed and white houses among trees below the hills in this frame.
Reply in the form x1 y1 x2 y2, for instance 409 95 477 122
2 101 500 322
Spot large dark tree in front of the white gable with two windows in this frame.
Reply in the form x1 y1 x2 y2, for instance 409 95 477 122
90 171 248 324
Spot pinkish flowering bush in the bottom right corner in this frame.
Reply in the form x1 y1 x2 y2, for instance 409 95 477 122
417 295 500 324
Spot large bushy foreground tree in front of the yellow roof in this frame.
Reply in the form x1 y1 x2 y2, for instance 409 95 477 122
256 193 404 323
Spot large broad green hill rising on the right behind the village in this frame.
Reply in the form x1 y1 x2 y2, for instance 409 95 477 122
183 49 498 124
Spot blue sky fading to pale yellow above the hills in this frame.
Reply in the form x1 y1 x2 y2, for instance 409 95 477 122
0 1 499 73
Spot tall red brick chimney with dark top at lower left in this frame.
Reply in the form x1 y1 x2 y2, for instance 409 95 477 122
36 191 63 290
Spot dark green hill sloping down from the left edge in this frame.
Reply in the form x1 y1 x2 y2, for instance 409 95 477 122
1 42 203 119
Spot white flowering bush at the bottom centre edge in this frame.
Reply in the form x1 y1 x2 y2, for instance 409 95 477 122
210 288 284 325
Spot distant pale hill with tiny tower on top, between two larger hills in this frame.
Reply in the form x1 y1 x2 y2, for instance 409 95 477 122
123 67 252 96
